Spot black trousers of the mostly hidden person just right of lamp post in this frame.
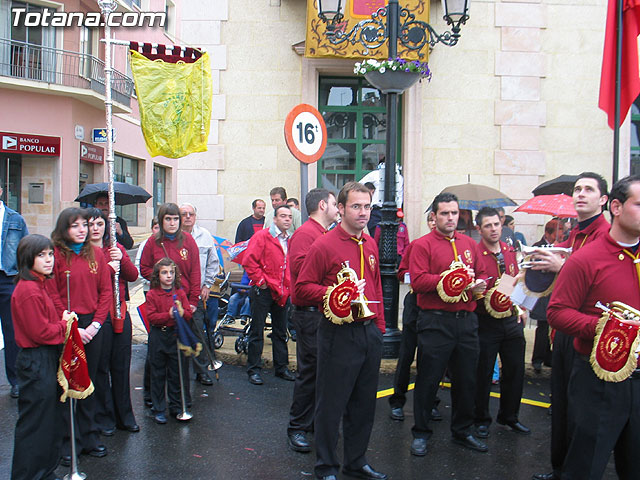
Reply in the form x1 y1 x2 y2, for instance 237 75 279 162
389 292 419 408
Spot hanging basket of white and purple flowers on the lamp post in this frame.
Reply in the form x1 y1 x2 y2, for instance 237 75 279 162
353 57 431 93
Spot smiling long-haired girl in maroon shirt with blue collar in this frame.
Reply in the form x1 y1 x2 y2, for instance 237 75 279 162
49 207 113 464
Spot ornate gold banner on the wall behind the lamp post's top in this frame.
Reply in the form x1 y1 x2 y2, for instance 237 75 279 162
304 0 429 62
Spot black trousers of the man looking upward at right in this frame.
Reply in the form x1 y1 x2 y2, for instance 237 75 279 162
551 330 576 473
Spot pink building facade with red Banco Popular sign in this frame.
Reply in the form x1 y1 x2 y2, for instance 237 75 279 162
0 0 179 235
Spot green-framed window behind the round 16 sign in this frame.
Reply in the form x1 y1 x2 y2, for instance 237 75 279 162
318 77 401 191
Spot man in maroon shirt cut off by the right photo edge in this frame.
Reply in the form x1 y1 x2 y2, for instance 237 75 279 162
547 175 640 479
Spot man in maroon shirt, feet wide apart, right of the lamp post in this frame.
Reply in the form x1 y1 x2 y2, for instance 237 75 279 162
409 192 487 456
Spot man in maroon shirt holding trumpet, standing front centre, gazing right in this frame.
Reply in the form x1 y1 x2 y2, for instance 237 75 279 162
295 182 387 480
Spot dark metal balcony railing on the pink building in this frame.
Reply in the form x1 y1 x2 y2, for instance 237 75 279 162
0 38 134 106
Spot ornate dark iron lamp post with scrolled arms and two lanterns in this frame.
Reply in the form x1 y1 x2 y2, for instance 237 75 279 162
317 0 470 358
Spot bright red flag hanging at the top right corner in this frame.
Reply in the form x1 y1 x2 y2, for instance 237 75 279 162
598 0 640 128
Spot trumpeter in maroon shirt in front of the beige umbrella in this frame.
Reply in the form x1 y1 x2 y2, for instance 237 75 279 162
475 207 531 438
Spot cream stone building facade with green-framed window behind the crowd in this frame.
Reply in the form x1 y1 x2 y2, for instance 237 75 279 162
178 0 624 246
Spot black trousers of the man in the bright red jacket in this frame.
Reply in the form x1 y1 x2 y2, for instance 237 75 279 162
247 287 289 375
